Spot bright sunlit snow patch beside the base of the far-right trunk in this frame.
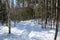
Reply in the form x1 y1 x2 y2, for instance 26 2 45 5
29 31 54 40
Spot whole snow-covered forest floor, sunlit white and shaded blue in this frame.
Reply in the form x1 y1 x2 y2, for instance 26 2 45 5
0 20 60 40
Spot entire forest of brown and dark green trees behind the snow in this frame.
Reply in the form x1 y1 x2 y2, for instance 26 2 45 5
0 0 60 40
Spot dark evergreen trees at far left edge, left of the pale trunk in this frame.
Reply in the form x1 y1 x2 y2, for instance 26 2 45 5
0 0 7 24
